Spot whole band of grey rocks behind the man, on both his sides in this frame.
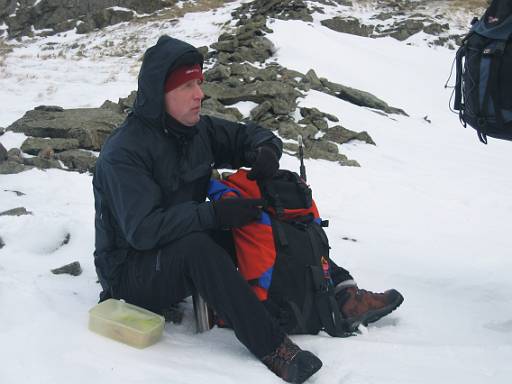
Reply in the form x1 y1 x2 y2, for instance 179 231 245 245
0 0 414 173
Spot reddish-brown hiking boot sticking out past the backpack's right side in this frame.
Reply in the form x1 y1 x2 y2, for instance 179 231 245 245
336 287 404 332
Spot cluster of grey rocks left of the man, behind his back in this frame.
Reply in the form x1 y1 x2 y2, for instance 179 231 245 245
0 103 123 174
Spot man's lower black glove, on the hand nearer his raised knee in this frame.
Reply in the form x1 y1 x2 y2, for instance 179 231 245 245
212 197 263 229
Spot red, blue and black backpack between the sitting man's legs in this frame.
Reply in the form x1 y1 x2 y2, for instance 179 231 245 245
209 170 351 337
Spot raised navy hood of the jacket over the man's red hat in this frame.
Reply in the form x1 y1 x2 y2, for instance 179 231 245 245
133 35 203 126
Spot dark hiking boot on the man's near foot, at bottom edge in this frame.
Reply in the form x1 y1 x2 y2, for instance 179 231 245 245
261 336 322 383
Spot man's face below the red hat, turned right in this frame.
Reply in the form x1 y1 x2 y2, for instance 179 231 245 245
165 79 204 127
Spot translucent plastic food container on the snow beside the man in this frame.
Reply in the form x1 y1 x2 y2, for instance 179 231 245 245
89 299 165 348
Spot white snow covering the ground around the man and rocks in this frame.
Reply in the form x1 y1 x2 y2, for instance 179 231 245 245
0 3 512 384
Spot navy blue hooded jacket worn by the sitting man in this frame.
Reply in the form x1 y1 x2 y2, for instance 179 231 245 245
93 36 282 291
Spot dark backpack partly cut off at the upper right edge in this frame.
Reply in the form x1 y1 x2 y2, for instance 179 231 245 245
454 0 512 144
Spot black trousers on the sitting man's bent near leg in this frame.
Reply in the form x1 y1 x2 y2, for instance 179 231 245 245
114 232 284 359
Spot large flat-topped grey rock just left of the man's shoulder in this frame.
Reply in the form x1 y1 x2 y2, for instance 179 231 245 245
7 108 125 151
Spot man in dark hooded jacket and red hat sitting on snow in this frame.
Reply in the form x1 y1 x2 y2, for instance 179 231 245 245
93 36 402 383
